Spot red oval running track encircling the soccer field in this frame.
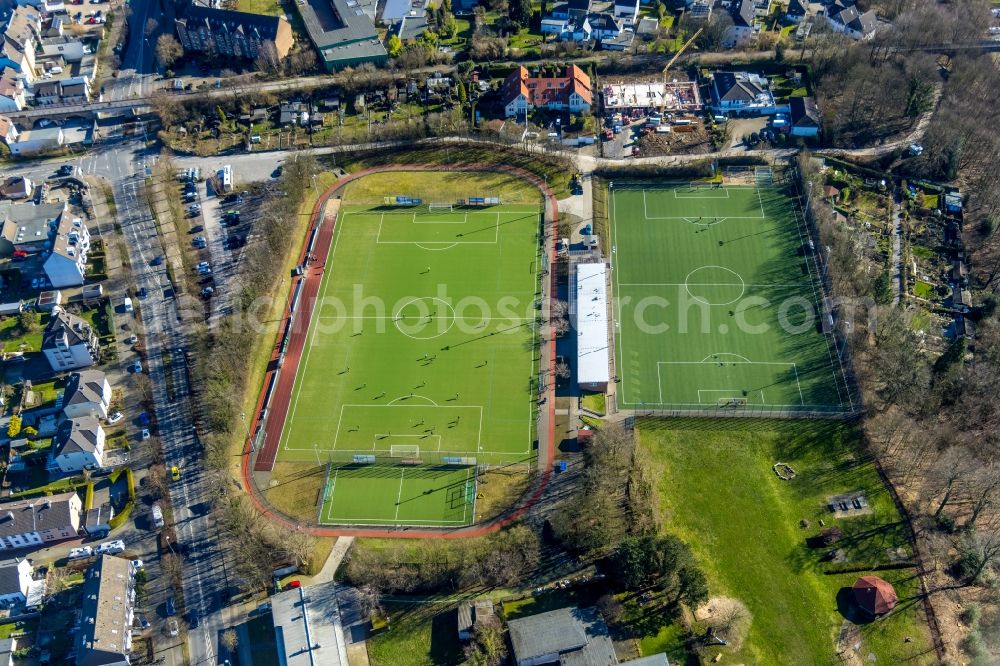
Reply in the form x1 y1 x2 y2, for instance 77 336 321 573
242 164 559 539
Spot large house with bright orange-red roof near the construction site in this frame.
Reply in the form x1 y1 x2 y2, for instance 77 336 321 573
500 65 594 118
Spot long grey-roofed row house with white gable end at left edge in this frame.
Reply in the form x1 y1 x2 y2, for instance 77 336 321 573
0 491 83 550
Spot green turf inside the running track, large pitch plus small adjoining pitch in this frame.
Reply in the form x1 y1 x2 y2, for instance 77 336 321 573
279 197 541 527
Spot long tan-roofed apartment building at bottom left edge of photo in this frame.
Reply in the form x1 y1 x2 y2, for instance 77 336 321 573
76 555 135 666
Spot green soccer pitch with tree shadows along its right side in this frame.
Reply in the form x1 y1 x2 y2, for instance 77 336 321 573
610 182 853 413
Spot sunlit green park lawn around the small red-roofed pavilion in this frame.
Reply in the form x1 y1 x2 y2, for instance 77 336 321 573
639 419 935 664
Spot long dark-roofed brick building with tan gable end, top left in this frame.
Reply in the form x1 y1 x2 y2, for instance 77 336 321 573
174 3 294 61
